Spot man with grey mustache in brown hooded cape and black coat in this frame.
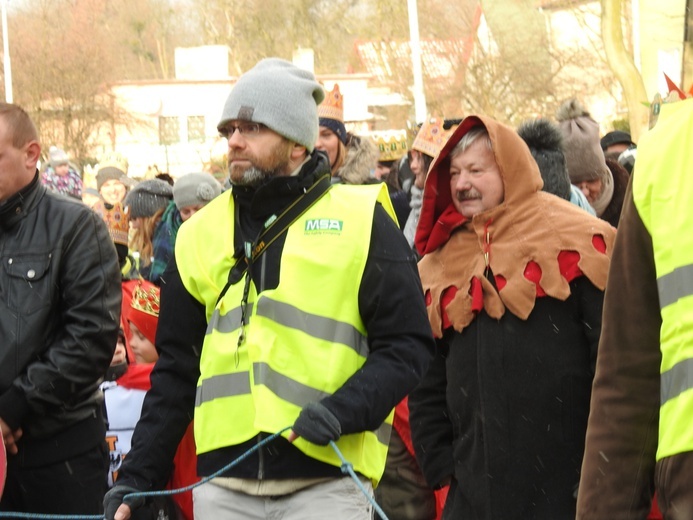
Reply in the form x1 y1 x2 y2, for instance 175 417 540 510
409 116 614 520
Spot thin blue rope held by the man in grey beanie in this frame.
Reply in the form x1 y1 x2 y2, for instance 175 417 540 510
0 426 388 520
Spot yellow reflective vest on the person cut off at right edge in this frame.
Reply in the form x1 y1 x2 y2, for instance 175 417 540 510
624 99 693 460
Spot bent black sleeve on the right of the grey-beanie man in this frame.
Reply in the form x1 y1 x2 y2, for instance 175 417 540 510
321 205 435 434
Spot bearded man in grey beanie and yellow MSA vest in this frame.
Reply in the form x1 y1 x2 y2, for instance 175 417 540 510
104 58 434 520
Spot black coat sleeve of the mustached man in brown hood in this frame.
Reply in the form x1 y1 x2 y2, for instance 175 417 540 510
409 339 455 488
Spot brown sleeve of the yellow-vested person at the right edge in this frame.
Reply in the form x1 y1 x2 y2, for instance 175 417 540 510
577 178 662 520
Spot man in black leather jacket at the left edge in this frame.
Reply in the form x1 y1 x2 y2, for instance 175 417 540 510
0 103 121 514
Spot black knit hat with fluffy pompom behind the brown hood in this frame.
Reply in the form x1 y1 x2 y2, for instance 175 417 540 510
517 119 570 200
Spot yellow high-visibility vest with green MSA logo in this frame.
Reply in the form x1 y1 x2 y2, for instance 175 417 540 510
176 184 394 483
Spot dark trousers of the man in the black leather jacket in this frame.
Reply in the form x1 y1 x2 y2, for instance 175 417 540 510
0 441 109 515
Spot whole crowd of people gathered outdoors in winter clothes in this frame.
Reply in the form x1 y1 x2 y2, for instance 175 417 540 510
0 58 693 520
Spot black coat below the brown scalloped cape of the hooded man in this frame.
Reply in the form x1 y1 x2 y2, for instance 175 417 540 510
409 277 603 520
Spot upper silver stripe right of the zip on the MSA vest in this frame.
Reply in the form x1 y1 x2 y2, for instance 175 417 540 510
257 298 368 357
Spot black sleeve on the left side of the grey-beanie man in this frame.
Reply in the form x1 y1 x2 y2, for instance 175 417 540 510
118 258 207 491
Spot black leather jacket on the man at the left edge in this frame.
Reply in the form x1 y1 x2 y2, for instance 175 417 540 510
0 174 121 465
